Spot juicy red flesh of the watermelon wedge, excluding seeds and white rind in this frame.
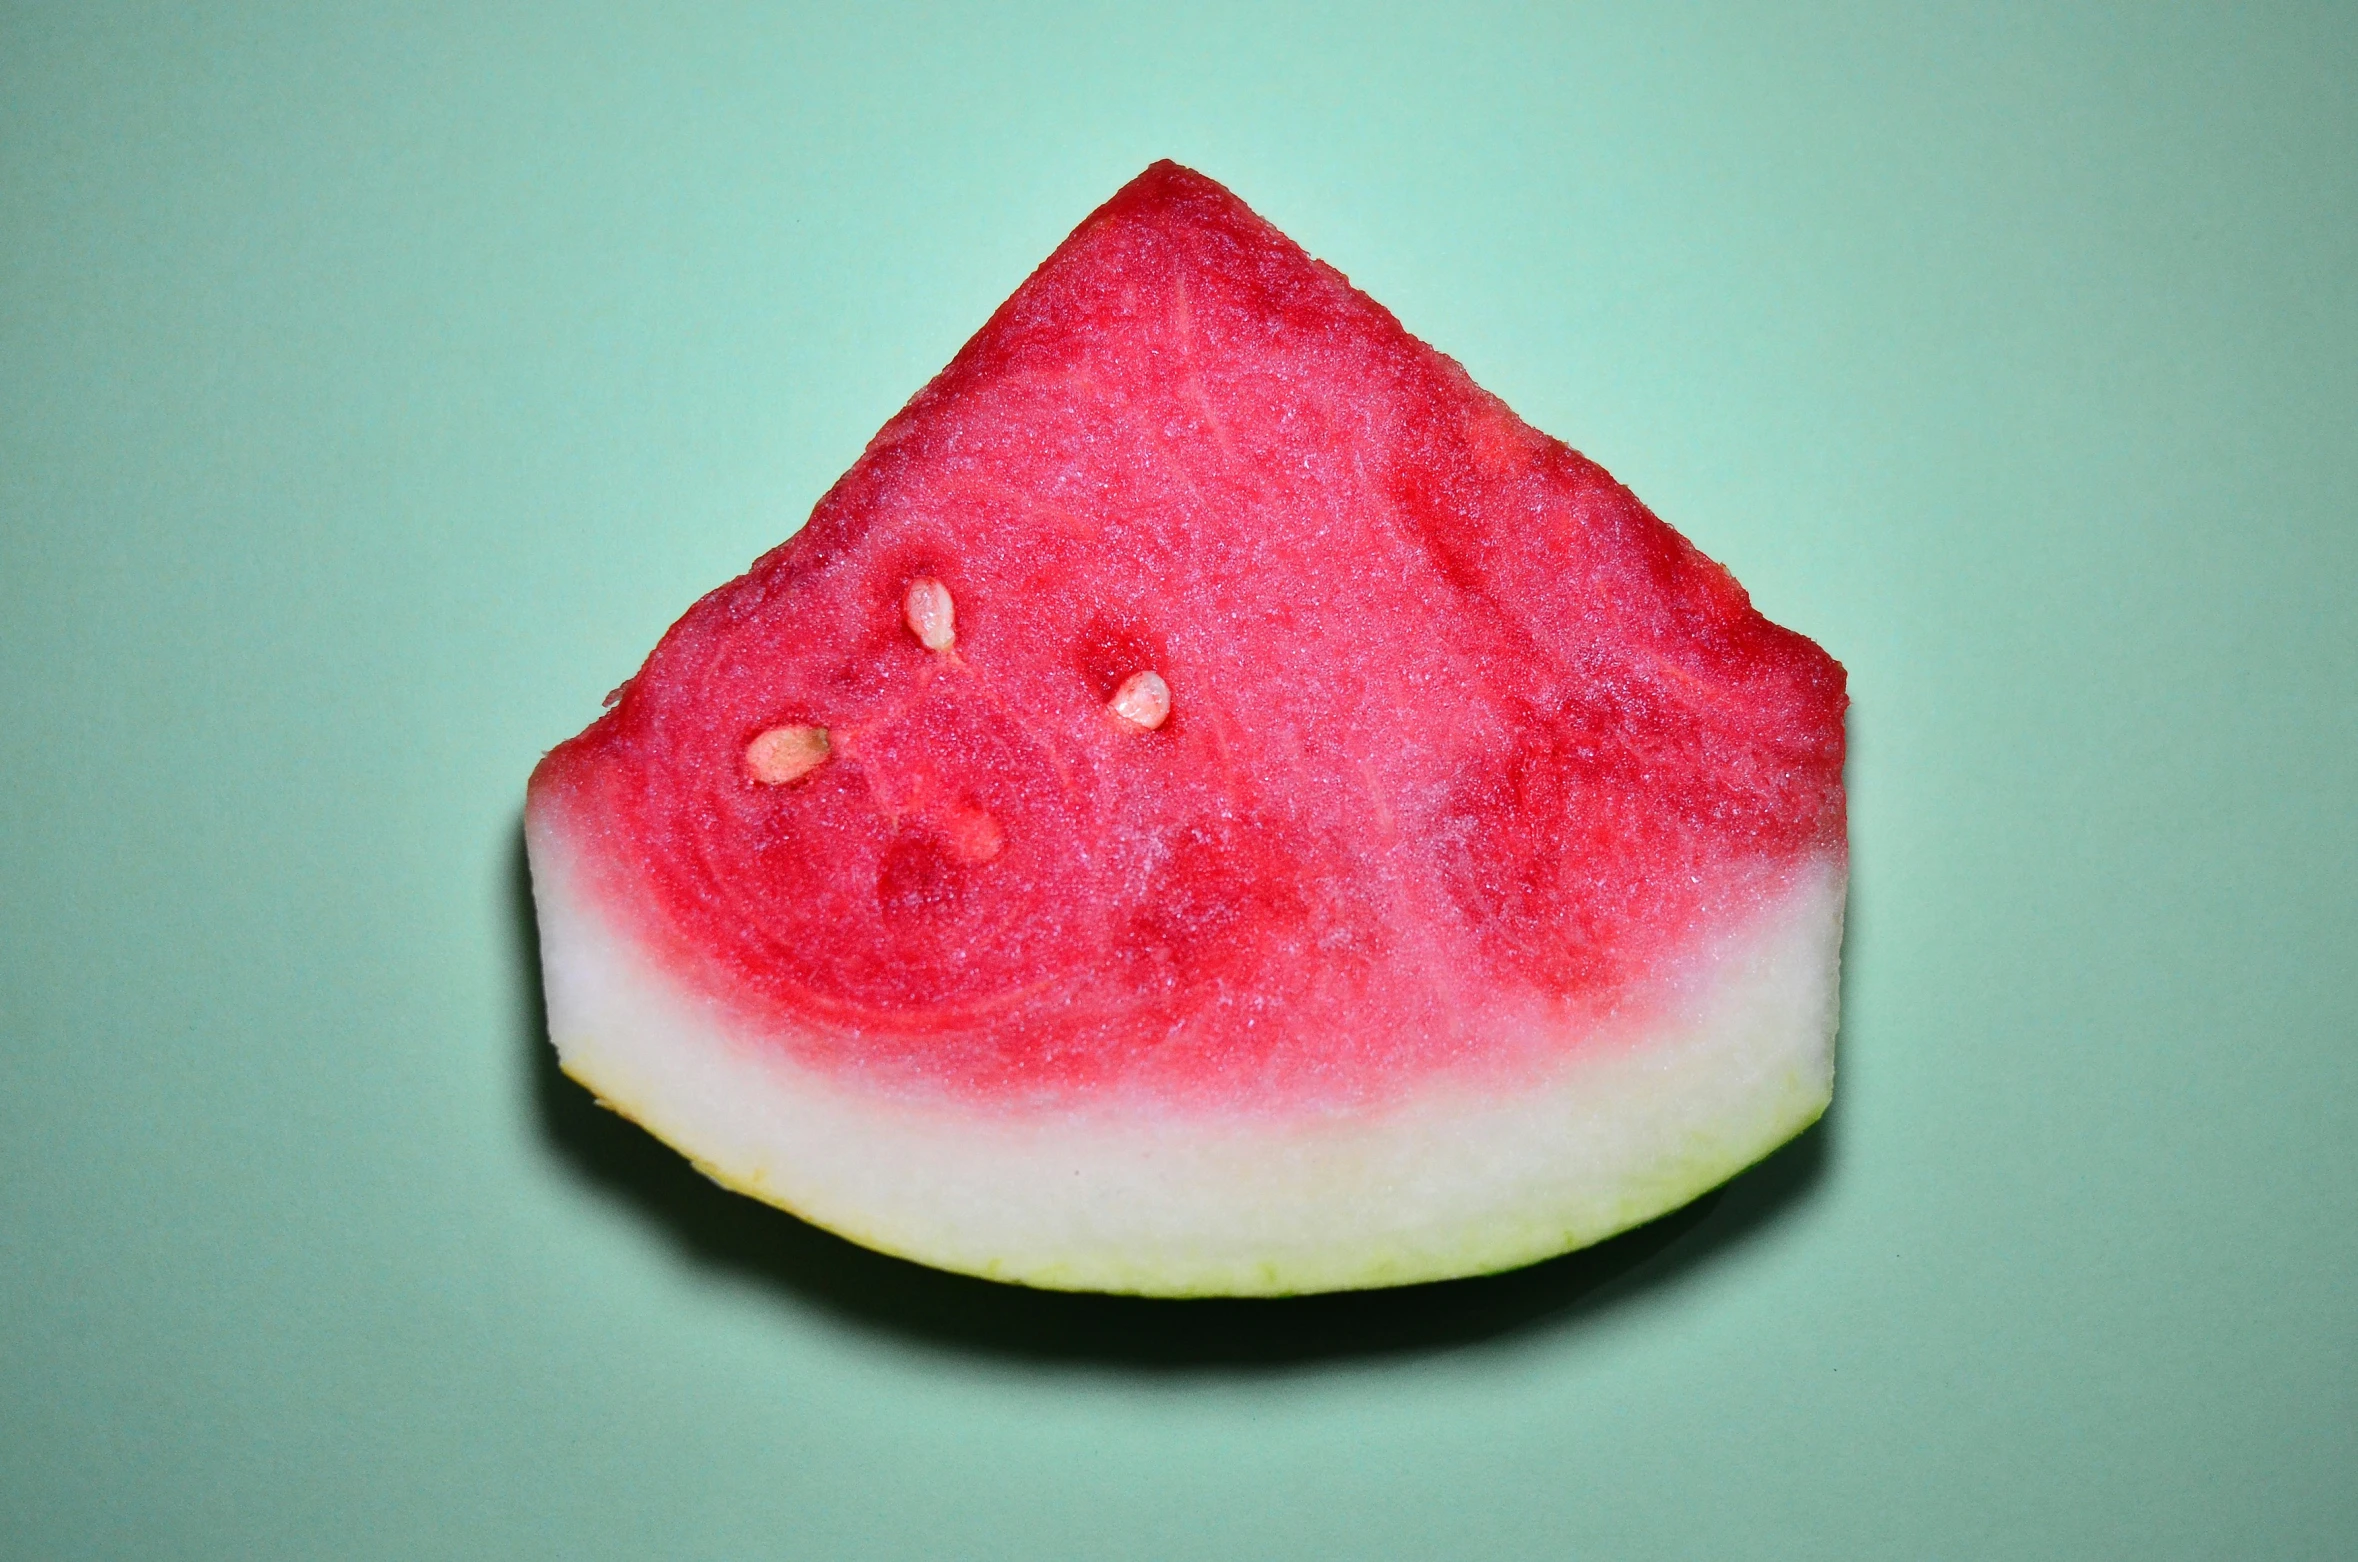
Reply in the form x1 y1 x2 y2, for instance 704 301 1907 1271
533 163 1844 1114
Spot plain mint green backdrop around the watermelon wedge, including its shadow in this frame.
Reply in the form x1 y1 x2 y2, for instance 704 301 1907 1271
0 5 2358 1560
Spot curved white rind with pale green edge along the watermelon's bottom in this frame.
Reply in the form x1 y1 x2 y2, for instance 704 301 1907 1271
526 809 1846 1295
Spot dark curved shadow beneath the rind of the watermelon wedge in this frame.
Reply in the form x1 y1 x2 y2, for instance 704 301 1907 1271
505 831 1835 1369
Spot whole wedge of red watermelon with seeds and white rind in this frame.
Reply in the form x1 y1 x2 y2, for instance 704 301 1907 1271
526 163 1846 1295
